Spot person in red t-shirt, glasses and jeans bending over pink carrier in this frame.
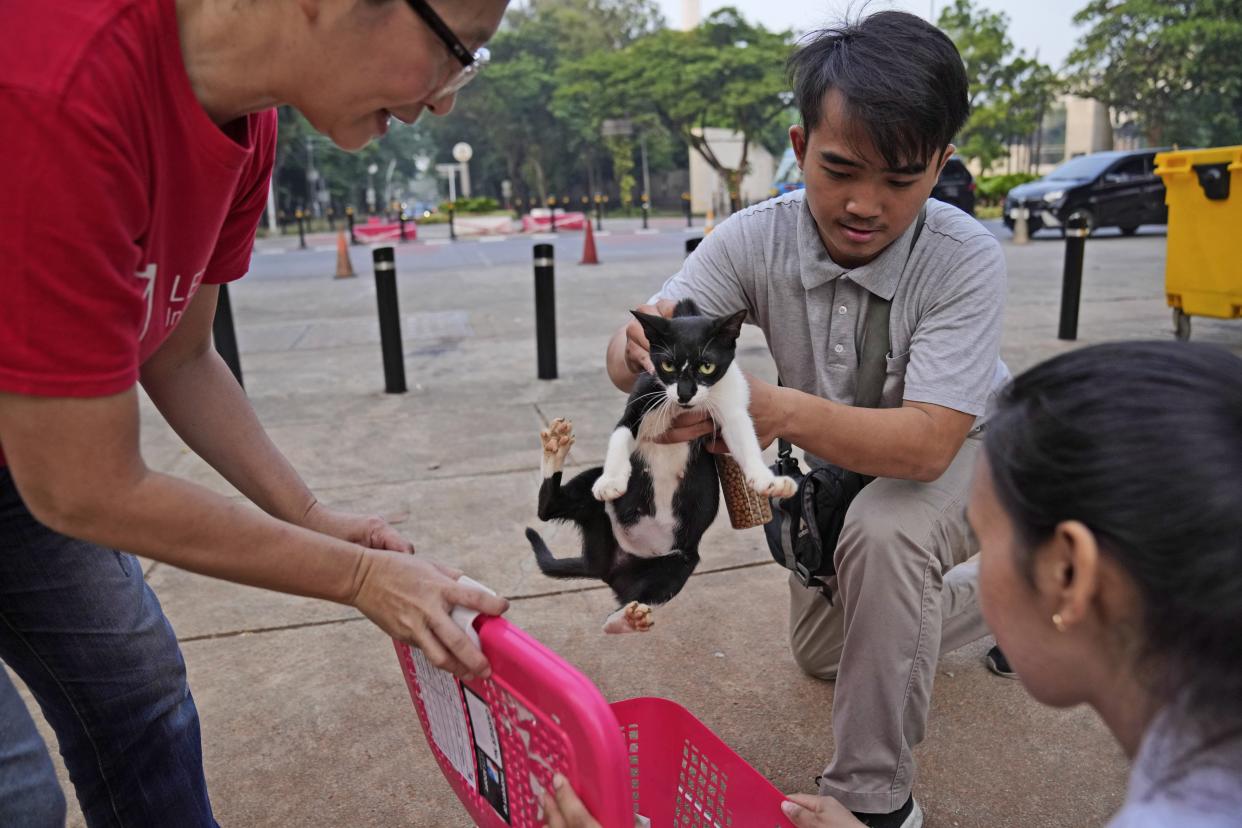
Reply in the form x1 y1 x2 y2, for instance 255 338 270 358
0 0 507 827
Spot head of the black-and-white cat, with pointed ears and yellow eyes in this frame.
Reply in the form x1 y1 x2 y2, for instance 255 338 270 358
631 310 746 408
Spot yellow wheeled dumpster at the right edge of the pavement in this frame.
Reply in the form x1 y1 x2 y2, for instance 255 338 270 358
1156 146 1242 339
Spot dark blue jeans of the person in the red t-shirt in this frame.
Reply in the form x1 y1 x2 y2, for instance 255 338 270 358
0 468 216 828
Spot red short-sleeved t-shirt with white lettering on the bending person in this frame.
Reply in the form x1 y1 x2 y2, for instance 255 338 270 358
0 0 276 463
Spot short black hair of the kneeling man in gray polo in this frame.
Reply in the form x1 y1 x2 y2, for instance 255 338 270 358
787 11 970 169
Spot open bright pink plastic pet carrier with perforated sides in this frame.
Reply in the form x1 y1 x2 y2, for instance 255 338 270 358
396 616 792 828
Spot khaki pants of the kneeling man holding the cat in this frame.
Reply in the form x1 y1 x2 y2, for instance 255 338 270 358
790 436 987 813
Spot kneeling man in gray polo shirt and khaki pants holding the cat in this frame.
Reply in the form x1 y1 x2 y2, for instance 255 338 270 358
607 11 1009 828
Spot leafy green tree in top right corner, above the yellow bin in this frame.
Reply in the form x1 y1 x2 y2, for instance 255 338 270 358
1068 0 1242 146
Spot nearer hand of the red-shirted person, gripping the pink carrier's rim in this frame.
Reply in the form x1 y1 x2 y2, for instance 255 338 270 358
350 550 509 680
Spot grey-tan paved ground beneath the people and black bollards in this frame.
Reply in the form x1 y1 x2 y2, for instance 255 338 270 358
12 224 1242 828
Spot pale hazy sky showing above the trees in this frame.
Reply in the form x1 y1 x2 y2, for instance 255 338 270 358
658 0 1087 68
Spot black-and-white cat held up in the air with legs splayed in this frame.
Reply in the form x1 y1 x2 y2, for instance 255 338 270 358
527 299 796 633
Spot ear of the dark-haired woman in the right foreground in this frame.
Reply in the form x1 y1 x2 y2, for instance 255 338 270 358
1035 520 1100 632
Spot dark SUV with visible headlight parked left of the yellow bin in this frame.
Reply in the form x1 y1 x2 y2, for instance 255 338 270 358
1005 149 1169 236
